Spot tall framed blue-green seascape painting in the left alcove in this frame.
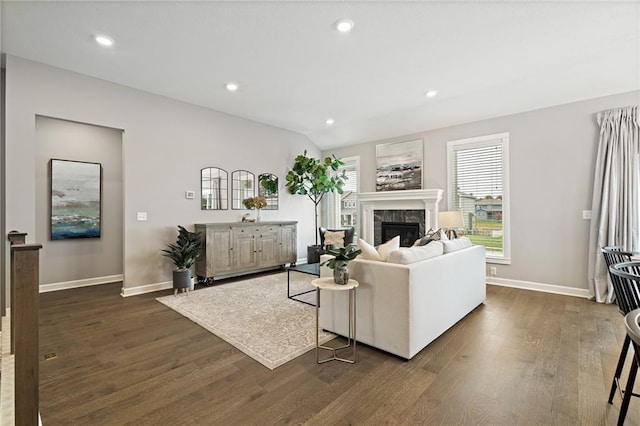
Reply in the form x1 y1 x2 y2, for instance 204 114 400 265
50 159 102 240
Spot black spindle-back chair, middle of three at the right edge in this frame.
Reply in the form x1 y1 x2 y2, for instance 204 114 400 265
609 262 640 425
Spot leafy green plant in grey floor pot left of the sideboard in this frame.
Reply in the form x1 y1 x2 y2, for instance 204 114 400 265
162 225 202 294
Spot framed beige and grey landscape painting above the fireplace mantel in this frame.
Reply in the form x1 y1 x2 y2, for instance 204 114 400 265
376 139 422 191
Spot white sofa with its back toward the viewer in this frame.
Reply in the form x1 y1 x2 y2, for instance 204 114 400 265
320 242 486 359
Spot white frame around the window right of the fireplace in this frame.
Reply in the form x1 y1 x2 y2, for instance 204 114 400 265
447 132 511 265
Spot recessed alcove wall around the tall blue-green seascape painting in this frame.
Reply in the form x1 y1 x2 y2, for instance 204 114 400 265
35 116 123 286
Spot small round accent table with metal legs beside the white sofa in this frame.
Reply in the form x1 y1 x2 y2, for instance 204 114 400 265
311 278 359 364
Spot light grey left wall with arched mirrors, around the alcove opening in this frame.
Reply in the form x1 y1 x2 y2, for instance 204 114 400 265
5 55 319 293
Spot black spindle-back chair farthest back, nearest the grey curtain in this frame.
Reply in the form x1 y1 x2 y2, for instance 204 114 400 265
601 246 640 404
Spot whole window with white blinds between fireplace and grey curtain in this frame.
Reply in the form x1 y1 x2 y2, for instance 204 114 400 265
447 133 510 263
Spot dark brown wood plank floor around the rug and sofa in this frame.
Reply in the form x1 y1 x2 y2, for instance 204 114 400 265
40 274 640 426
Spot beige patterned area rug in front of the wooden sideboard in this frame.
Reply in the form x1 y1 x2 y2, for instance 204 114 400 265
156 272 335 370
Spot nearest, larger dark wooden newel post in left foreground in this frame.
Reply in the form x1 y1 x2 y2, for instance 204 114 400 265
11 244 42 426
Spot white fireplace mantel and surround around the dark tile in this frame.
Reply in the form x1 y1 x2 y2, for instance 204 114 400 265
358 189 444 244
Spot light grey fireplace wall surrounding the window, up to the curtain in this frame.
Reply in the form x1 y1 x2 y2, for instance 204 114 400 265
332 92 640 294
